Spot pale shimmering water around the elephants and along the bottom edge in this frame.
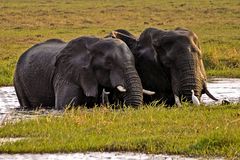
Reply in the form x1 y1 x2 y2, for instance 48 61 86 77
0 78 240 160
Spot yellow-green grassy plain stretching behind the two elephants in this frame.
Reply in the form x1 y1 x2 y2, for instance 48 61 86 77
0 0 240 86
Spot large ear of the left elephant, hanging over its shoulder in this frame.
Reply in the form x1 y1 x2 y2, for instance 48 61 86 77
55 37 99 97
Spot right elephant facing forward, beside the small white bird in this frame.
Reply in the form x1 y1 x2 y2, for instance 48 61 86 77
106 28 218 106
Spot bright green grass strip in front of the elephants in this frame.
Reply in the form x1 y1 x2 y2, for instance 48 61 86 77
0 104 240 159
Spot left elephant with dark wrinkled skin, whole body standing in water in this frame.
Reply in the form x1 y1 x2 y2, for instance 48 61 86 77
14 37 143 109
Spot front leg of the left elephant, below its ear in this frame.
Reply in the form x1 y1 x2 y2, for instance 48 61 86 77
55 83 82 109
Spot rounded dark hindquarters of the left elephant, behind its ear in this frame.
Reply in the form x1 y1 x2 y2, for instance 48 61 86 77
14 39 66 107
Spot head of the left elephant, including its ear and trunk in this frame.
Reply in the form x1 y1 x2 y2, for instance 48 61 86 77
55 37 143 106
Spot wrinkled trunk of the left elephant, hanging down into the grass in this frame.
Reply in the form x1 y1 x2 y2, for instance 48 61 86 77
123 65 143 106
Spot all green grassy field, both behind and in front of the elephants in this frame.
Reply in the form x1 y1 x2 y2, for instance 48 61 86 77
0 0 240 159
